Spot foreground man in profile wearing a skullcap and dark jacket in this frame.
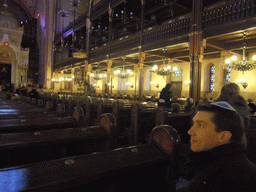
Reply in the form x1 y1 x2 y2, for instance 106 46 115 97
176 101 256 192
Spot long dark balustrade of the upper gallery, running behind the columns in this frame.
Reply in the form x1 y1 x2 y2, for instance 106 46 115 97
53 0 256 69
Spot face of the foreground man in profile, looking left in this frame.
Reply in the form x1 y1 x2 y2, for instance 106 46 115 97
188 111 221 152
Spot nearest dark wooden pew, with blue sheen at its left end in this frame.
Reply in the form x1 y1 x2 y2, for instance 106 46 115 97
0 126 179 192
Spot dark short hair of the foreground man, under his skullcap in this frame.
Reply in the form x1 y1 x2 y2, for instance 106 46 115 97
196 104 244 143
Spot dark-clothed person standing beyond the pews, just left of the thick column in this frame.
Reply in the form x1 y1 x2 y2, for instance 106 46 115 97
158 83 173 108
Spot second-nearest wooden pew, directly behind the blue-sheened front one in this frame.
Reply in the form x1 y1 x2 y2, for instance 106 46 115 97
0 114 117 167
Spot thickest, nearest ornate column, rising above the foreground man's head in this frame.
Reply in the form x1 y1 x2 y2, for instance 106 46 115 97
189 0 203 101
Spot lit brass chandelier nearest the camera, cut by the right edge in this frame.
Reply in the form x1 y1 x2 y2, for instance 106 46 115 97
225 31 256 74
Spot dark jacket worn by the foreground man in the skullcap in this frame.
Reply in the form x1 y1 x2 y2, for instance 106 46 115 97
178 144 256 192
